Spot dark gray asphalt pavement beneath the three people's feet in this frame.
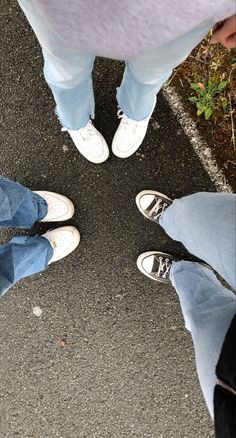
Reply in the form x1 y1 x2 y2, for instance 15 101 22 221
0 0 215 438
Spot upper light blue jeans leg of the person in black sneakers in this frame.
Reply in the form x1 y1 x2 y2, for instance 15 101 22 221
159 192 236 288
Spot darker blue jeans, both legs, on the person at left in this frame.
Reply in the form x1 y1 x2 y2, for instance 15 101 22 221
0 176 53 296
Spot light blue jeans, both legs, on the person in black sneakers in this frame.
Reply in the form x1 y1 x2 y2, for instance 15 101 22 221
160 192 236 417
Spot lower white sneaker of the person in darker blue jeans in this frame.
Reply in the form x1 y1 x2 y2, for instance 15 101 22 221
42 226 80 264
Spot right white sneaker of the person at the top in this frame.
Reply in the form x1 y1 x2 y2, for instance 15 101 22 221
112 99 156 158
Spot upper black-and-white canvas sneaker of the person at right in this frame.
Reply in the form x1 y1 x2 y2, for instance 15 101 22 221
136 190 173 223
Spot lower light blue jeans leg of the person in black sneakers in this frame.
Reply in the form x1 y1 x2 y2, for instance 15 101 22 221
170 261 236 417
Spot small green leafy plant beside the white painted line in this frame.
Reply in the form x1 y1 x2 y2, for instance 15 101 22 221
189 75 228 120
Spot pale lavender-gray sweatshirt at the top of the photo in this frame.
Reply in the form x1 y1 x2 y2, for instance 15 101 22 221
29 0 235 60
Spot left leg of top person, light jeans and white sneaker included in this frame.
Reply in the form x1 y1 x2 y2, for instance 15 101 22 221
18 0 109 164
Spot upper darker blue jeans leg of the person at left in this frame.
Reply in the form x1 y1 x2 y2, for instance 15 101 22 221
0 176 48 228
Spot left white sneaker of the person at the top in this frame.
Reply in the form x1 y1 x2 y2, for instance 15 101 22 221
62 120 109 163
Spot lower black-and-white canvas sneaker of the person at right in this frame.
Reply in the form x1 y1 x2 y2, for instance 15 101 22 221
137 251 179 283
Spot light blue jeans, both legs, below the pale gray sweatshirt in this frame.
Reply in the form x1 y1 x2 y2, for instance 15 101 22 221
18 0 213 129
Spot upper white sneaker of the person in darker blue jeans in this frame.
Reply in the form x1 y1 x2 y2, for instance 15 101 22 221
34 190 75 222
